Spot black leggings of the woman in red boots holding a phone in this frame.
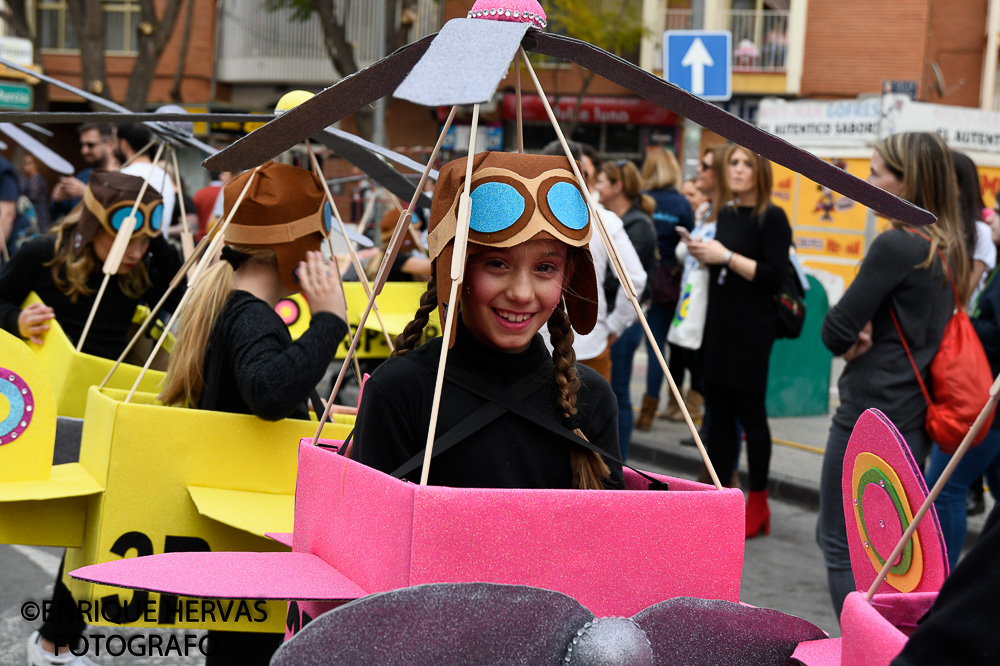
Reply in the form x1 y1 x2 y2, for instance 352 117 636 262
705 381 771 491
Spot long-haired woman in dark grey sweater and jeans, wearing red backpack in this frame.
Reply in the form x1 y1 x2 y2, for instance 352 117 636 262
816 132 968 614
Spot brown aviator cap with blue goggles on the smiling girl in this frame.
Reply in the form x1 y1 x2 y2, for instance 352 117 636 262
427 152 597 341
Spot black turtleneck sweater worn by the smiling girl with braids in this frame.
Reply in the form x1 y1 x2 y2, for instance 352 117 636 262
352 321 624 488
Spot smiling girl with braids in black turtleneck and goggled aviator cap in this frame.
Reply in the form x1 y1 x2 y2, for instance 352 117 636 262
351 153 624 489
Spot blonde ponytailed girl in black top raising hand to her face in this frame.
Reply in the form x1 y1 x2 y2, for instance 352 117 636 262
160 162 347 666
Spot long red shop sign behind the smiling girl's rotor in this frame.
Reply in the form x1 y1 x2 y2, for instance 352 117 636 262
503 93 678 126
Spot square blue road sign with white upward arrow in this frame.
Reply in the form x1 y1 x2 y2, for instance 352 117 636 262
663 30 733 101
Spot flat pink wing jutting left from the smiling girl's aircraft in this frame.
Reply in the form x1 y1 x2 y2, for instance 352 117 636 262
70 553 367 600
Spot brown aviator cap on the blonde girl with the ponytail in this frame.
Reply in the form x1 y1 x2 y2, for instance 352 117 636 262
223 162 332 293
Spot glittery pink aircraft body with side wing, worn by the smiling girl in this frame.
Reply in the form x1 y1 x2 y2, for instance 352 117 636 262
73 440 744 623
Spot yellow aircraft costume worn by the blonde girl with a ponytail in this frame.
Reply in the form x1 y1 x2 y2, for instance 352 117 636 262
0 328 353 632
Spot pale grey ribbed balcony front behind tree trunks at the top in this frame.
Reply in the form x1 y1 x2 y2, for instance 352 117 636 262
217 0 441 86
